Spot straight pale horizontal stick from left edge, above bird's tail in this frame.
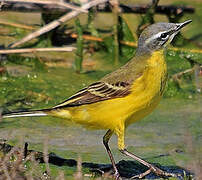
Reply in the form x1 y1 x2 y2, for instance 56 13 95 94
0 47 76 54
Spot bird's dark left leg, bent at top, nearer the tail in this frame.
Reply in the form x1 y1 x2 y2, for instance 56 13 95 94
103 130 120 180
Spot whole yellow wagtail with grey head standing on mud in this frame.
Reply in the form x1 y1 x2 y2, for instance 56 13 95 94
2 20 191 179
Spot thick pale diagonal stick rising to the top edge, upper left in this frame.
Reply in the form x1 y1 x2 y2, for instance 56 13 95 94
10 0 108 48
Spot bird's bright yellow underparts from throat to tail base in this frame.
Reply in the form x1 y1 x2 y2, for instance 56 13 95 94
49 50 166 130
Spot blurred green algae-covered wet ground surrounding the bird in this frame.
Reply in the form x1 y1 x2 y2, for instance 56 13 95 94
0 0 202 177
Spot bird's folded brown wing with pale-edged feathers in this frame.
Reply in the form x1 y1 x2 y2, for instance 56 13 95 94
54 82 130 108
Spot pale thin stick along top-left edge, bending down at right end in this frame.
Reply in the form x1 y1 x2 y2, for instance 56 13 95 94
3 0 88 13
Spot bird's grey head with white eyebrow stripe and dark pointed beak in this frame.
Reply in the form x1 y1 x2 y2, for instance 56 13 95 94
136 20 192 55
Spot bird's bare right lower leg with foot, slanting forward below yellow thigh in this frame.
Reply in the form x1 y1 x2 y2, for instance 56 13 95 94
120 149 178 178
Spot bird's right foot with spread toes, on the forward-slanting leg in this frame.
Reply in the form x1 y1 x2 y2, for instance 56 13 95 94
131 166 181 179
